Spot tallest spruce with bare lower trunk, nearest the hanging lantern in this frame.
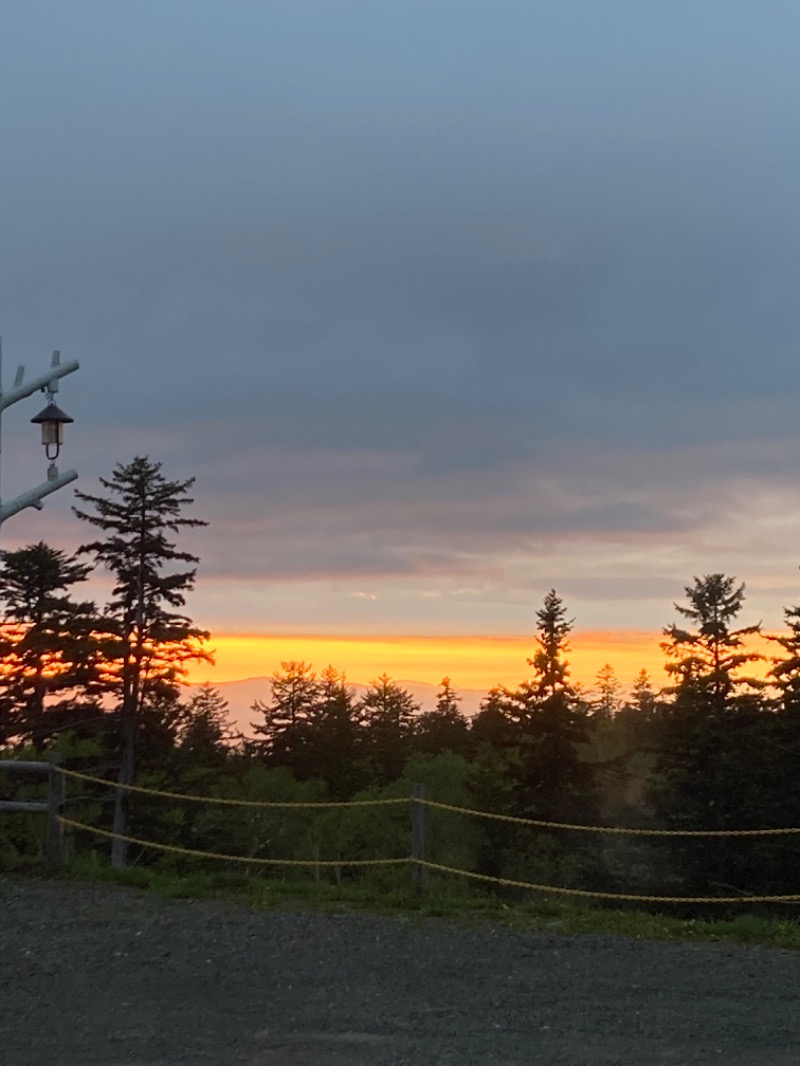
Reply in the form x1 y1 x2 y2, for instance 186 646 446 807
73 456 209 867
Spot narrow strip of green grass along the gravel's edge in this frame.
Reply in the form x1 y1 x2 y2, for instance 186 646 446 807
19 858 800 951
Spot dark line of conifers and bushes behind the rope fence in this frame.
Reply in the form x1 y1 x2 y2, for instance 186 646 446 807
0 457 800 897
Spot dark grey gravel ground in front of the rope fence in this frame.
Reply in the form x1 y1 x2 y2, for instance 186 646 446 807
0 879 800 1066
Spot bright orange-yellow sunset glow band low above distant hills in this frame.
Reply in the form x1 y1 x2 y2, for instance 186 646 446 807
189 630 682 690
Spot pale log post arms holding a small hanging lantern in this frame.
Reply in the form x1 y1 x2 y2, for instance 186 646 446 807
0 341 79 524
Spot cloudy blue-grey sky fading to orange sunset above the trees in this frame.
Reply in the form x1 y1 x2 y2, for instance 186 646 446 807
0 0 800 684
